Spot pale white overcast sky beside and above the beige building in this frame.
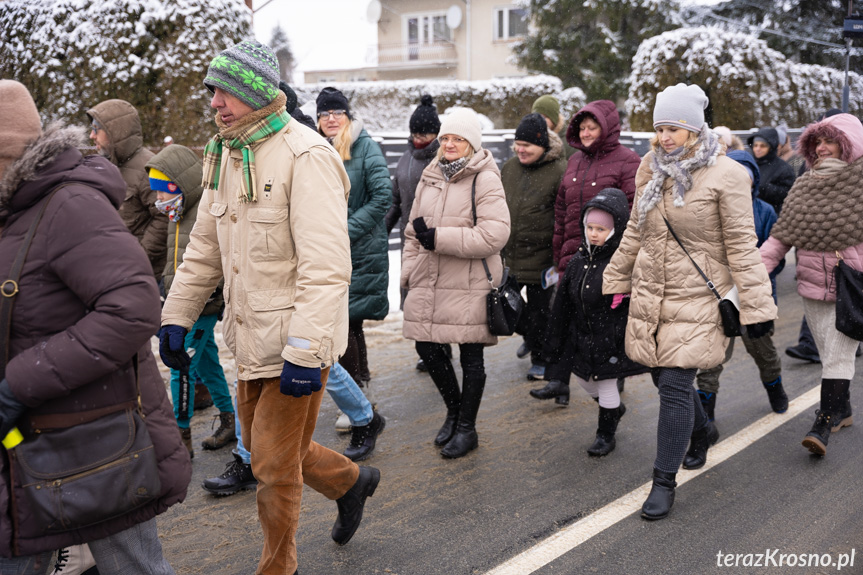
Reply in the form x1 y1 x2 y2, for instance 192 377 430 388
253 0 721 83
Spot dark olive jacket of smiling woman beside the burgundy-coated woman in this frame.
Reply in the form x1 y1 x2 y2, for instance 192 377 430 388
501 132 566 284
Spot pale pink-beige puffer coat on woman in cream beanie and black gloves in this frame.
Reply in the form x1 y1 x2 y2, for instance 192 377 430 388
401 149 510 345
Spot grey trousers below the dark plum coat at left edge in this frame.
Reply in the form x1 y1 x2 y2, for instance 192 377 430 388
0 517 174 575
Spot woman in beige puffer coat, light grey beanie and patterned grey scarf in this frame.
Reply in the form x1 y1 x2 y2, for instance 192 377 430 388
603 84 776 519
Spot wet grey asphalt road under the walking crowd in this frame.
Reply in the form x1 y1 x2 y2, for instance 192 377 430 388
159 265 863 575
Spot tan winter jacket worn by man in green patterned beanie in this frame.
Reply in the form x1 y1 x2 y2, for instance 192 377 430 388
162 120 351 380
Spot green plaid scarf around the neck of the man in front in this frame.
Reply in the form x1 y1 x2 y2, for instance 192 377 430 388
201 110 291 202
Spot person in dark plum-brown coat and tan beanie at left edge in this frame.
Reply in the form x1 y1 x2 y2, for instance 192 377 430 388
0 80 192 575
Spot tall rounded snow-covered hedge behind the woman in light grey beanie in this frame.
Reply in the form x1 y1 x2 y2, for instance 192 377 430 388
626 28 863 130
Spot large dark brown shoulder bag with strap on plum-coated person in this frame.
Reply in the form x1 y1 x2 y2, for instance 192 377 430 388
0 186 161 539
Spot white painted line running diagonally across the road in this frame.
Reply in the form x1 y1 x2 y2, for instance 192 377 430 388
486 386 821 575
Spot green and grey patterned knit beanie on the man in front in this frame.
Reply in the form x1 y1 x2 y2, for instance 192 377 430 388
204 40 279 110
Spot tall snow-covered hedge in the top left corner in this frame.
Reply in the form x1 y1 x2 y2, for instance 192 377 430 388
0 0 251 144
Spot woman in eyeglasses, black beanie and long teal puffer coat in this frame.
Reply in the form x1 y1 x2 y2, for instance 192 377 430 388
316 88 392 424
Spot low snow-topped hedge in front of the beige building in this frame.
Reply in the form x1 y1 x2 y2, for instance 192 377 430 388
293 75 586 132
